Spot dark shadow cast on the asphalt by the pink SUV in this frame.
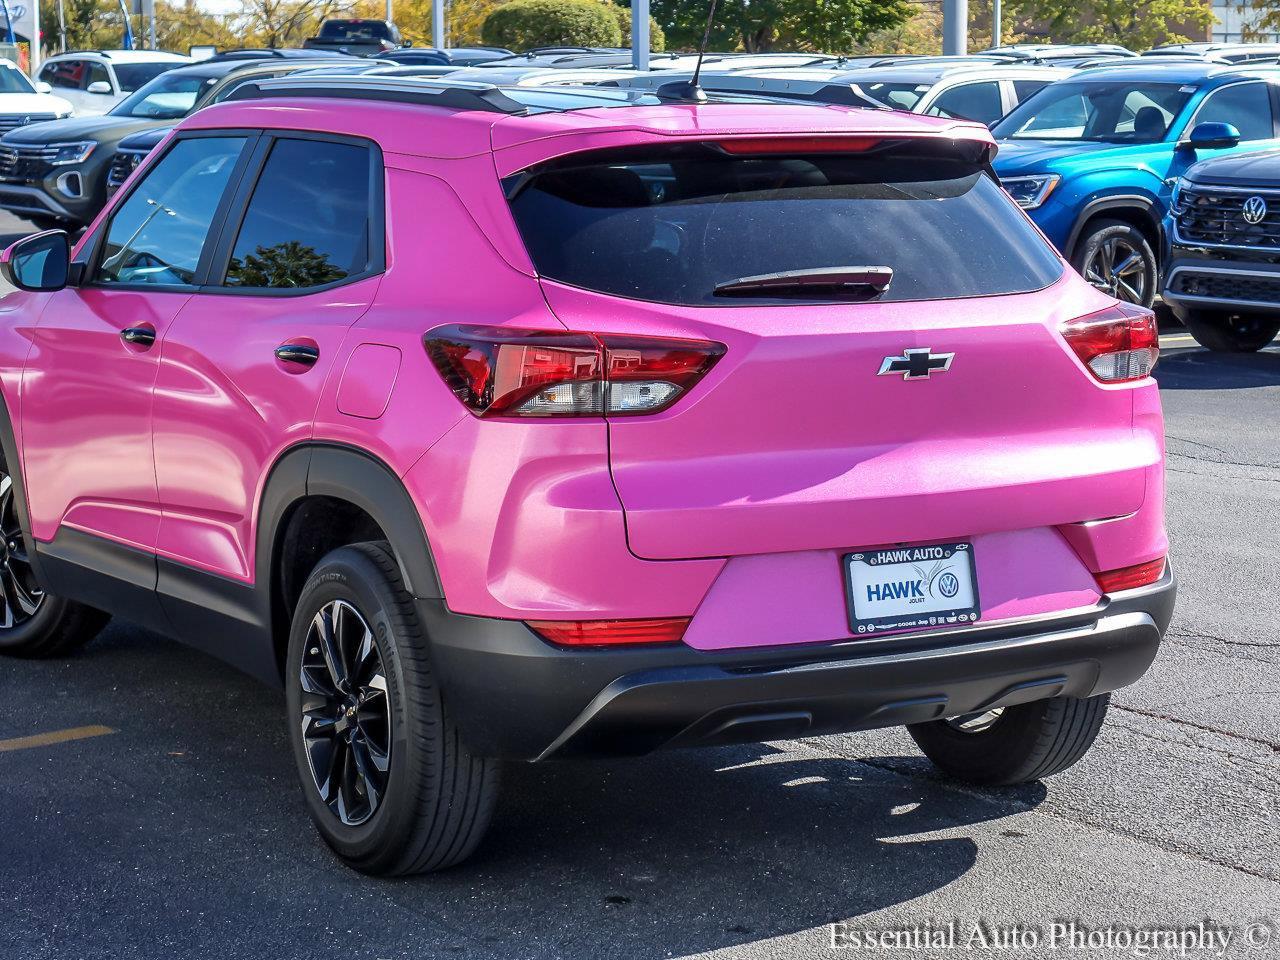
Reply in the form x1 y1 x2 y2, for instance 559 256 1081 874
0 625 1046 960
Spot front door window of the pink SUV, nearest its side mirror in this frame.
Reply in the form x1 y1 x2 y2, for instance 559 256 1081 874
93 137 246 284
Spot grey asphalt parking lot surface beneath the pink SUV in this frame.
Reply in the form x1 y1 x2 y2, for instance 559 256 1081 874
0 218 1280 960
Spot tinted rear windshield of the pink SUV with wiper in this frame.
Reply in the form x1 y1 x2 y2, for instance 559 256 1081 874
504 143 1062 306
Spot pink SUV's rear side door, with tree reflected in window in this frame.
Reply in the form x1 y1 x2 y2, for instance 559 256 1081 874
154 133 384 586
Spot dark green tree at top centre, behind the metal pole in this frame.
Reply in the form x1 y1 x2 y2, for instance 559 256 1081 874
653 0 915 54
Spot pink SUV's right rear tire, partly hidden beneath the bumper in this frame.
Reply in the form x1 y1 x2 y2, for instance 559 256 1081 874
906 694 1111 786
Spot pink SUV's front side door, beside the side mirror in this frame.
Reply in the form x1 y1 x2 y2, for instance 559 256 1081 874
20 137 256 552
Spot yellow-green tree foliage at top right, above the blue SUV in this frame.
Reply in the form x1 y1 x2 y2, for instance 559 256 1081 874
1010 0 1208 50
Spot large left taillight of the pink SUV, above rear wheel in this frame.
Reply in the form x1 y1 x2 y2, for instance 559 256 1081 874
424 326 724 417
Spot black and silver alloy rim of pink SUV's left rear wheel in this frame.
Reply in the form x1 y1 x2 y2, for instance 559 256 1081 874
301 600 392 827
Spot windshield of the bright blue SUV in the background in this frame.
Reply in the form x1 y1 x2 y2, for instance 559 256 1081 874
991 81 1194 143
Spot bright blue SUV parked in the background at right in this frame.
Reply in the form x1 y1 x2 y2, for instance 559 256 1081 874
992 61 1280 307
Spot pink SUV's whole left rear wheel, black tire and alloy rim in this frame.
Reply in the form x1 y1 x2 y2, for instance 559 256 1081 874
285 543 499 876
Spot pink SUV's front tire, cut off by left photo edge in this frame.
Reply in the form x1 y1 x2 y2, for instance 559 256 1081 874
0 456 111 658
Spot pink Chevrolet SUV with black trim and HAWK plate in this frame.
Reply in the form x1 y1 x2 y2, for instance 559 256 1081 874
0 76 1174 874
